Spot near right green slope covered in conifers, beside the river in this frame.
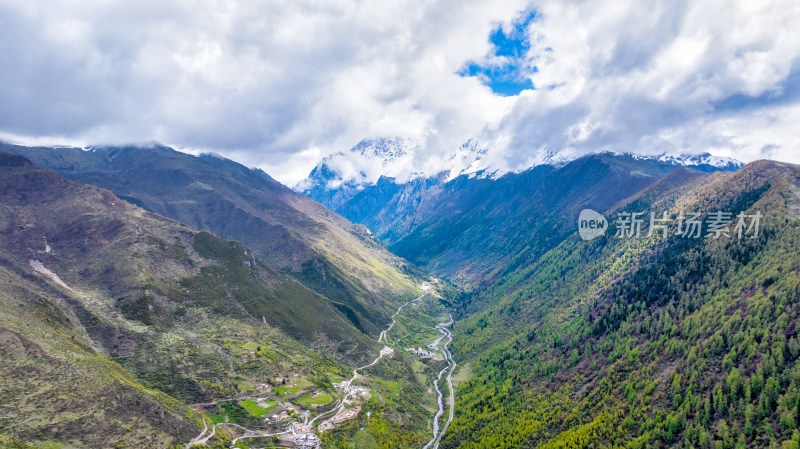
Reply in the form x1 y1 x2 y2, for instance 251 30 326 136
442 161 800 448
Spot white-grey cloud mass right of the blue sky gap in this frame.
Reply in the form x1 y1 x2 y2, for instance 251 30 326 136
482 0 800 174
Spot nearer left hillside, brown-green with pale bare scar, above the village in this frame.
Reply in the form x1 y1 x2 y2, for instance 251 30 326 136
0 154 377 448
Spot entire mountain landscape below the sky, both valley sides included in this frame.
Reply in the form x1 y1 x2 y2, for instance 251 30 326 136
6 139 800 449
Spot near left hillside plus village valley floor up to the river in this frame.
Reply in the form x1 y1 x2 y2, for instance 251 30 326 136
0 153 446 447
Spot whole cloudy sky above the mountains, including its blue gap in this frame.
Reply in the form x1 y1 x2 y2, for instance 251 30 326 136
0 0 800 183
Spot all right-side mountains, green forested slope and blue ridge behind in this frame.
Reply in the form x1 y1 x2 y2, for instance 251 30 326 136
296 140 800 449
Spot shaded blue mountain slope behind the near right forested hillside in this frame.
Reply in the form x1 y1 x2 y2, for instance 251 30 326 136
308 153 737 286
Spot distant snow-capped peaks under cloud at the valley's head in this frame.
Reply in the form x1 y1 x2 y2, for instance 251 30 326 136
295 138 743 237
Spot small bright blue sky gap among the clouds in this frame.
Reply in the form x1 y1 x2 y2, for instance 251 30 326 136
458 12 536 96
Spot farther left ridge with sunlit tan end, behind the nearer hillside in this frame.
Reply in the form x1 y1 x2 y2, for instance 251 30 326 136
0 144 421 336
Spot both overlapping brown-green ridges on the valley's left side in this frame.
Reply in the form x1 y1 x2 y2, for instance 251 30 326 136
0 145 438 447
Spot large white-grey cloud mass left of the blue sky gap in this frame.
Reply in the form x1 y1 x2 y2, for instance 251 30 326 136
0 0 523 180
